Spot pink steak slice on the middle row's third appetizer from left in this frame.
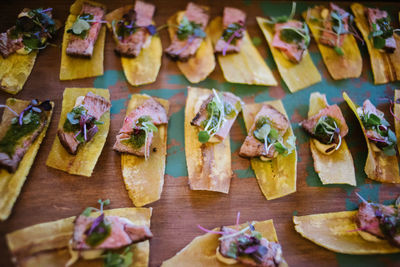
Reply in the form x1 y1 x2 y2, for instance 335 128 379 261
113 98 168 158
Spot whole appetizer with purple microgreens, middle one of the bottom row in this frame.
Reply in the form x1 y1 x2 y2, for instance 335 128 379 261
161 217 287 267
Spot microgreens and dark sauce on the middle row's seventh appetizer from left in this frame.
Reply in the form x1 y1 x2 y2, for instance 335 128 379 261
357 107 397 156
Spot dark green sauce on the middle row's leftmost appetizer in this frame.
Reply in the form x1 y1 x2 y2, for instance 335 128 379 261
0 111 41 157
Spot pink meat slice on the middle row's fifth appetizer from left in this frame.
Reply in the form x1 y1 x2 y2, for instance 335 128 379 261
239 104 290 158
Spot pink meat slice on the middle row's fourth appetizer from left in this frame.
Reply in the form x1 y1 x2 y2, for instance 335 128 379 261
190 92 241 141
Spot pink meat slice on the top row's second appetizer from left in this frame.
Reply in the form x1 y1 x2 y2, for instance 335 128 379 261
66 2 105 58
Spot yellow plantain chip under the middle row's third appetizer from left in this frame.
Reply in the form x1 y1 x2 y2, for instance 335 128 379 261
121 94 169 207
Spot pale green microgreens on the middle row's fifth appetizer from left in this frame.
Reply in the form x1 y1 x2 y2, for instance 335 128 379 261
253 117 296 156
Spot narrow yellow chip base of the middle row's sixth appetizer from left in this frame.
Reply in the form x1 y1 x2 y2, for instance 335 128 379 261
308 92 356 186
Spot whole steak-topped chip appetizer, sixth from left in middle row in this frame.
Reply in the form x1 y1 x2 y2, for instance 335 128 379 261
300 92 356 186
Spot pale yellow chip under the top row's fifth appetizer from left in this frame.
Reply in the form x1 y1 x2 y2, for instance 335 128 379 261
210 17 278 86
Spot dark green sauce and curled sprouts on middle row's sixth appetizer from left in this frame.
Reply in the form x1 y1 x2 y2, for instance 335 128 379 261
314 116 342 150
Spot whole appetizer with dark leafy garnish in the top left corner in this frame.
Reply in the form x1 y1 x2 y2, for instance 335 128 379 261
0 8 58 94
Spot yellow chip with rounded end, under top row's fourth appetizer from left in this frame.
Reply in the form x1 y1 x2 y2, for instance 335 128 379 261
167 11 215 83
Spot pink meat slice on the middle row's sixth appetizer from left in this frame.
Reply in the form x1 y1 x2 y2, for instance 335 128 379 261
300 105 349 137
